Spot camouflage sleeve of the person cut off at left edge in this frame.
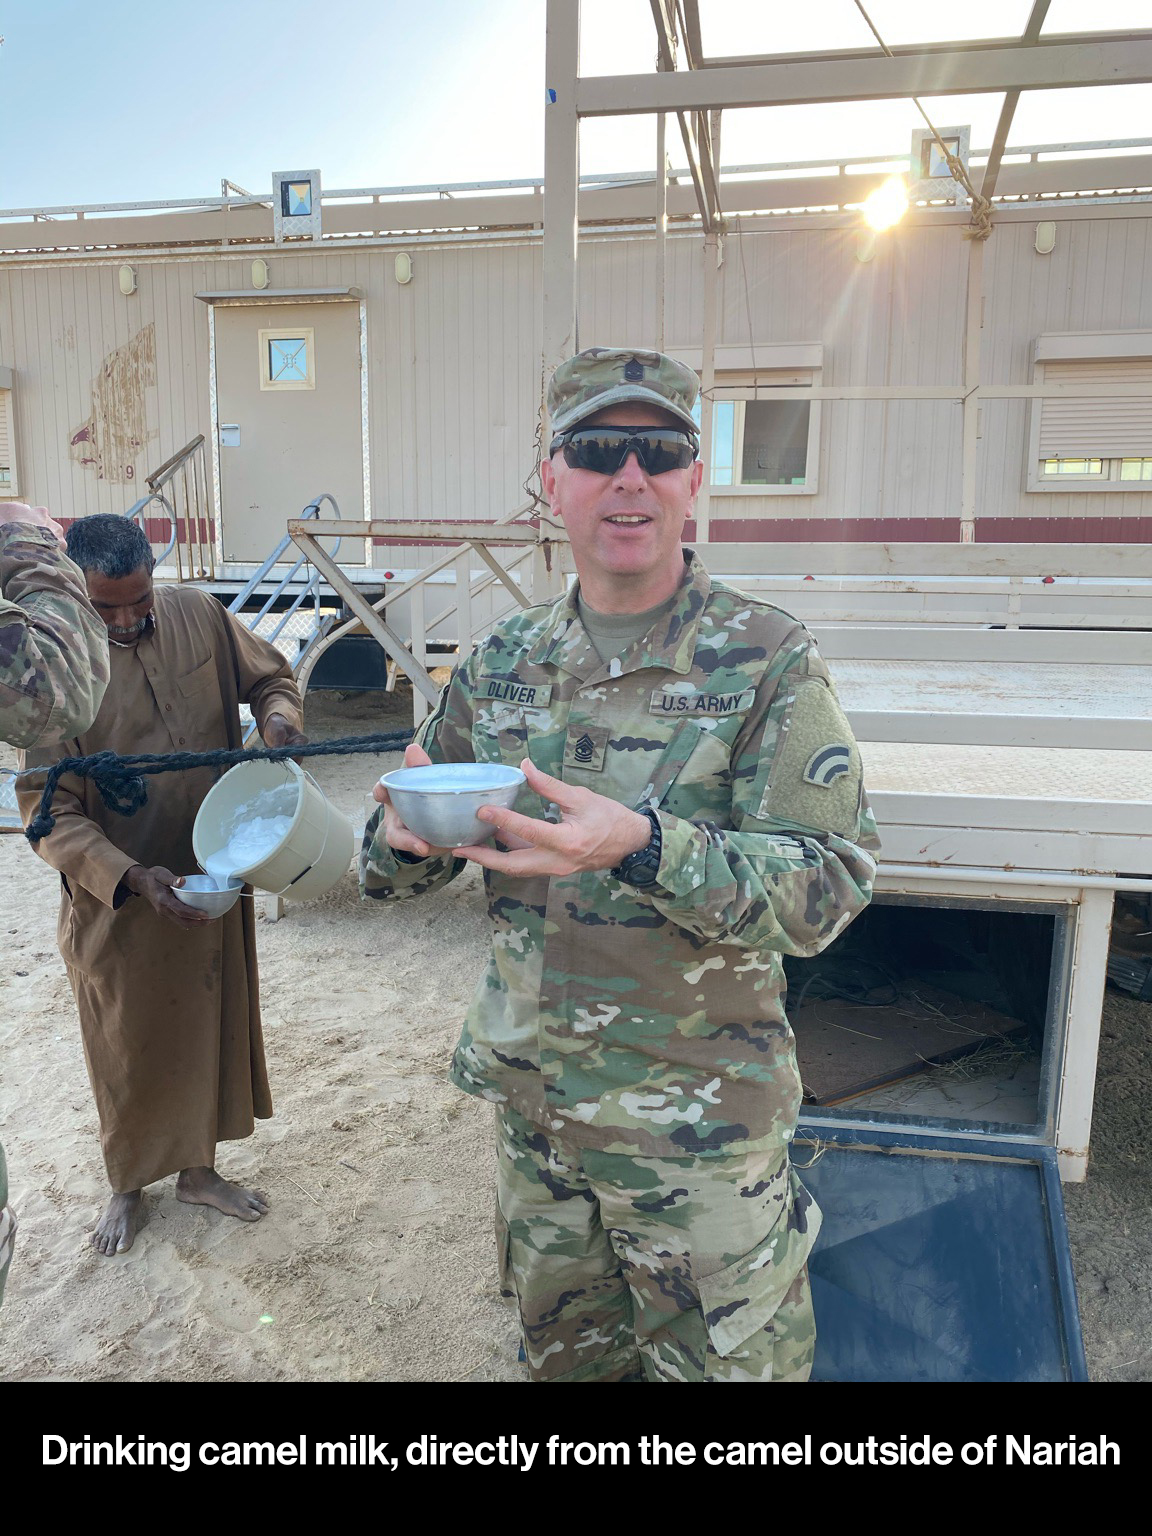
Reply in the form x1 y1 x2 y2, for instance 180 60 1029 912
0 522 108 748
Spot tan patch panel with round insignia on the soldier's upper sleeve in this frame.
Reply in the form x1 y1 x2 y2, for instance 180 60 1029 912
760 677 862 837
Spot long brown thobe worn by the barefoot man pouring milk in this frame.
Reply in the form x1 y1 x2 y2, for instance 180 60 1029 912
18 587 301 1193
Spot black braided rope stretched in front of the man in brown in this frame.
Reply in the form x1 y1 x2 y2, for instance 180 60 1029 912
18 731 412 843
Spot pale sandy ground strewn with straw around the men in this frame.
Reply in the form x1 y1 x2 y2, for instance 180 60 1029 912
0 694 1152 1381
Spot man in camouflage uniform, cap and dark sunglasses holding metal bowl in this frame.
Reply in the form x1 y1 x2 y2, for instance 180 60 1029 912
361 349 879 1381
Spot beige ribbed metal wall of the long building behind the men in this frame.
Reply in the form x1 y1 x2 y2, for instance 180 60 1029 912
0 207 1152 549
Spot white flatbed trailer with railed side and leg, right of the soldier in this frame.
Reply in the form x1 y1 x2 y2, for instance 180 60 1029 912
814 608 1152 1181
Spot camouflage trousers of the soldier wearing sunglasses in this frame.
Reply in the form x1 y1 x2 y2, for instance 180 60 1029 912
496 1109 820 1381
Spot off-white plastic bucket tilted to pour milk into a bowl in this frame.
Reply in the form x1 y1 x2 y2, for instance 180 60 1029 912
192 760 356 902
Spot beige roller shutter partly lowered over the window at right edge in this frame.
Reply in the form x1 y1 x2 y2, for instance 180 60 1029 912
1040 358 1152 459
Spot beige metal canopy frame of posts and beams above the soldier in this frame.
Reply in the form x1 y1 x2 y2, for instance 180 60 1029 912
541 0 1152 544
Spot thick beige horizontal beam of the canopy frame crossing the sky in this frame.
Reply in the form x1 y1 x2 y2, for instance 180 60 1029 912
577 38 1152 117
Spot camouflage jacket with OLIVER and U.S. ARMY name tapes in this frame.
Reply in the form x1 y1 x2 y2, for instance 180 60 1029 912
361 556 879 1157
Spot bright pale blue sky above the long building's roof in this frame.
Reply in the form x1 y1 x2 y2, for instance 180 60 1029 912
0 0 1152 207
